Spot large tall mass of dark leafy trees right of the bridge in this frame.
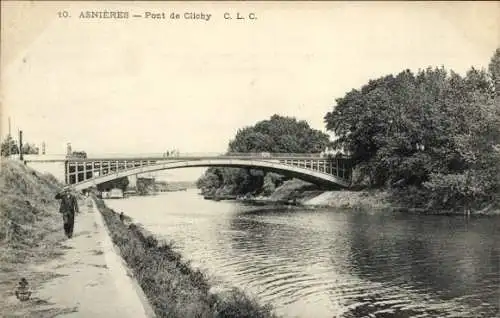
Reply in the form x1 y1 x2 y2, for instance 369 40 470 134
325 49 500 208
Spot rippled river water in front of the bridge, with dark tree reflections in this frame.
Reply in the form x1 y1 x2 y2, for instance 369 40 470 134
106 191 500 318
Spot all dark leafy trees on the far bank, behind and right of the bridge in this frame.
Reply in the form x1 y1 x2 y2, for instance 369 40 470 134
197 49 500 212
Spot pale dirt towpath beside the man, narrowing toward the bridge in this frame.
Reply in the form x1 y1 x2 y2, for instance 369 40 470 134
7 200 153 318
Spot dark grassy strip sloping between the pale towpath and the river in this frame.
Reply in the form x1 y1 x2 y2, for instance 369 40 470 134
96 199 276 318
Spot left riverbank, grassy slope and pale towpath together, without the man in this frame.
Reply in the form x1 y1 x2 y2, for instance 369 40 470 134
0 160 152 318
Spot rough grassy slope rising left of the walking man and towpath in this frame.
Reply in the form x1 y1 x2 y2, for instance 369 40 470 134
0 160 77 317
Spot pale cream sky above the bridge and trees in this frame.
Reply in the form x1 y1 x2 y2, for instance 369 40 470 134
1 1 500 180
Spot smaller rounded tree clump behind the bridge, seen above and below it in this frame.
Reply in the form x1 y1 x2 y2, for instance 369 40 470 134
197 115 329 194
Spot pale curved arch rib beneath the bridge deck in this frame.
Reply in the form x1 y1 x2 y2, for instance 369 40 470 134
70 158 349 190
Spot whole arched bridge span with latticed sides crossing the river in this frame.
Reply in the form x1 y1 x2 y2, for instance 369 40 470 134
61 153 351 190
